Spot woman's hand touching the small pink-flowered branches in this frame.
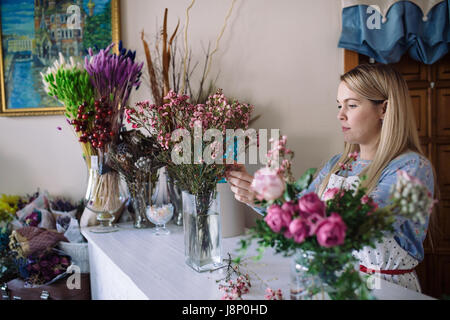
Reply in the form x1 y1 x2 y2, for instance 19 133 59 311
226 164 255 206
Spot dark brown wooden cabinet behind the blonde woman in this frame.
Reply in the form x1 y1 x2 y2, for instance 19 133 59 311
344 50 450 298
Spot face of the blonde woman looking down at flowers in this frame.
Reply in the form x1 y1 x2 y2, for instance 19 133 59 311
337 81 384 145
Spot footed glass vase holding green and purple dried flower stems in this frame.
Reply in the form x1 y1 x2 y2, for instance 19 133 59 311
85 156 127 233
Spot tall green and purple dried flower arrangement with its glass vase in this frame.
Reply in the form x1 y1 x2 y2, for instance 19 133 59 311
42 42 143 222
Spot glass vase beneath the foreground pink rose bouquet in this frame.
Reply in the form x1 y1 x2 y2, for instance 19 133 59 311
290 250 325 300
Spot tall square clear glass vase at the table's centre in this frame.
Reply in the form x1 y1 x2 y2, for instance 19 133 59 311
182 191 223 272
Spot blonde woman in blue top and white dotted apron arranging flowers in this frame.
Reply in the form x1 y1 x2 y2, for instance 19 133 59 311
227 64 435 292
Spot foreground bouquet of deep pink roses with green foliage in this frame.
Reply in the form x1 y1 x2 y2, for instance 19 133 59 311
236 136 434 299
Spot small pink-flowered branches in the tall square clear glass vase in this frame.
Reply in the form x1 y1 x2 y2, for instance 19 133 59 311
126 89 254 271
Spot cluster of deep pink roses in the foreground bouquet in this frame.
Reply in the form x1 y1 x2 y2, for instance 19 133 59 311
264 190 347 248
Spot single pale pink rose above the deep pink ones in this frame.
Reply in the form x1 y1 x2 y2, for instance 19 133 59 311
251 168 285 201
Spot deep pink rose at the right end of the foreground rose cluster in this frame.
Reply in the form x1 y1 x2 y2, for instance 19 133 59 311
316 212 347 248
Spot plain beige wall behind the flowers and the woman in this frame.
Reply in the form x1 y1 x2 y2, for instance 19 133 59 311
0 0 343 228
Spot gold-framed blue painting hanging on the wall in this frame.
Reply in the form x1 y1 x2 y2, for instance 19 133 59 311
0 0 120 116
